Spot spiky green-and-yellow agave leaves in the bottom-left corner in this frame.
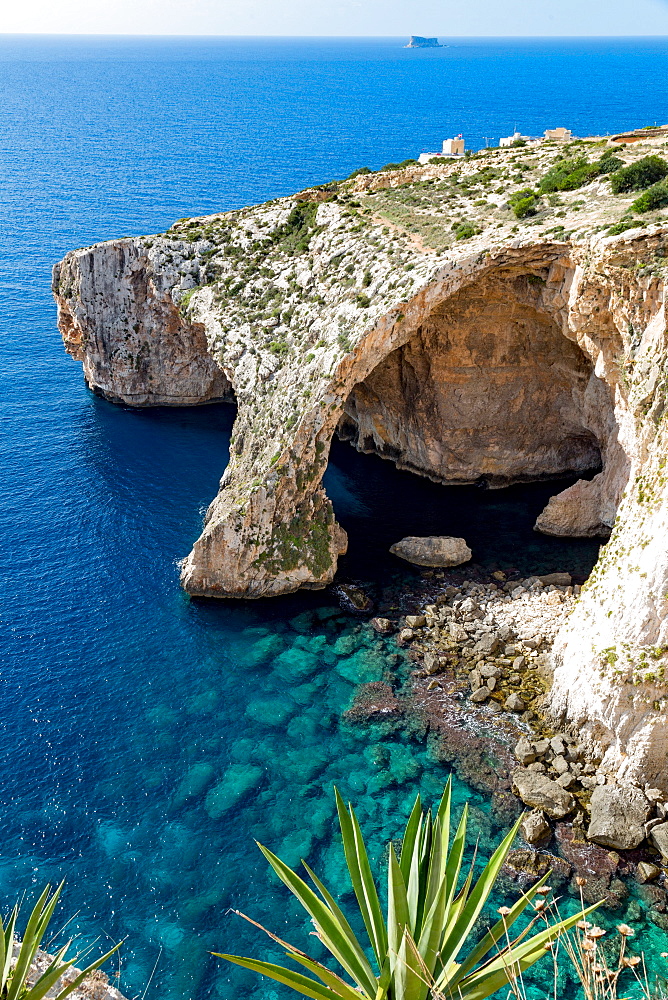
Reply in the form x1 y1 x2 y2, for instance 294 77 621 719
0 882 121 1000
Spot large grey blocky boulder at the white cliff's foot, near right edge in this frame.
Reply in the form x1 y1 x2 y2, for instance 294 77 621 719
587 785 648 851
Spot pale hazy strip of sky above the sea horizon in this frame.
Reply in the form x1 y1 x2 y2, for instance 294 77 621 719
0 0 668 39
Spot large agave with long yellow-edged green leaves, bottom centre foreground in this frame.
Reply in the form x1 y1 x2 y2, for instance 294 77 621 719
214 781 596 1000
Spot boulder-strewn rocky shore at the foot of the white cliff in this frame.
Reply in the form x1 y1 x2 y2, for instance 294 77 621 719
347 567 668 916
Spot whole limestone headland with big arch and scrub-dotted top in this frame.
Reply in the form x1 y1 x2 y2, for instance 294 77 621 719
54 133 668 785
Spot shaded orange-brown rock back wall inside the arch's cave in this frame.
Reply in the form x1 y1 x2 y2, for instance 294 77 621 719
340 266 605 486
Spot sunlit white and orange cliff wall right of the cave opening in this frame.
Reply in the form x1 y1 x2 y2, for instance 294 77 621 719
550 235 668 792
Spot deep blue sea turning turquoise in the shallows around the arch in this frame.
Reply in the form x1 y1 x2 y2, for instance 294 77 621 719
0 36 668 1000
